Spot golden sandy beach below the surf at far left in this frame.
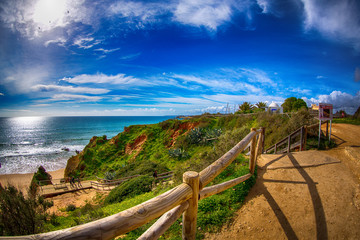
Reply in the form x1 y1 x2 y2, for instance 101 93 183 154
0 168 65 193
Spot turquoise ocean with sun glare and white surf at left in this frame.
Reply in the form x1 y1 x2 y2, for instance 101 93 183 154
0 116 174 174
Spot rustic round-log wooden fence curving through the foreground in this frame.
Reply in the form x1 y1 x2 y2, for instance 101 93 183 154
4 128 265 239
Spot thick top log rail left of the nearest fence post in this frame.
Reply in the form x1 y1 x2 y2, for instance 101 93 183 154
17 183 193 240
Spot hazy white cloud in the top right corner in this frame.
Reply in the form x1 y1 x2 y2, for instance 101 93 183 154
301 0 360 51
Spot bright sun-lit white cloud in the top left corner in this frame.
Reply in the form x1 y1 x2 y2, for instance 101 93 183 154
0 0 90 39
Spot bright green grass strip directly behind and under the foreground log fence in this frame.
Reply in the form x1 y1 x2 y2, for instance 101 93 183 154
46 155 255 239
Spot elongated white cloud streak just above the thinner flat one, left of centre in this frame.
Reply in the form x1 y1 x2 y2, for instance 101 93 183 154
62 73 150 86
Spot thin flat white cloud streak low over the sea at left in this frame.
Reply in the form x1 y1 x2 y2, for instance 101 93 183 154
31 84 110 94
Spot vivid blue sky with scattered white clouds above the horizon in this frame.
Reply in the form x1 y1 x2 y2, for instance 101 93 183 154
0 0 360 117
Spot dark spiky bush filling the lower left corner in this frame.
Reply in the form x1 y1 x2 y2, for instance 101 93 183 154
0 185 52 236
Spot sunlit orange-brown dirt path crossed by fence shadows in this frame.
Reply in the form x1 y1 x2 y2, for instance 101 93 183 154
206 124 360 239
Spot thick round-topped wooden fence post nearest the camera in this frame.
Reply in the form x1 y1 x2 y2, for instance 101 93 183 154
182 171 200 240
